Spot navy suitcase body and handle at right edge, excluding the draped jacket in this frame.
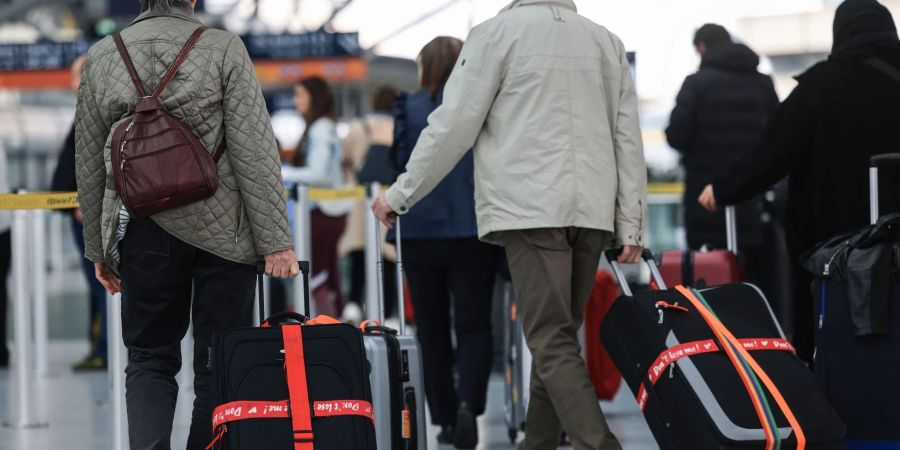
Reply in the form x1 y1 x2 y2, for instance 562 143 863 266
807 154 900 450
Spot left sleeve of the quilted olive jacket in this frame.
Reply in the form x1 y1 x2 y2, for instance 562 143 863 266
75 56 112 262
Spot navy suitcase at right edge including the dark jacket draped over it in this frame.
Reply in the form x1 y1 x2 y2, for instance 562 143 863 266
803 154 900 450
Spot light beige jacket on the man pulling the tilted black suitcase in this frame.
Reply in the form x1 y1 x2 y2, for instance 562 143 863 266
386 0 647 246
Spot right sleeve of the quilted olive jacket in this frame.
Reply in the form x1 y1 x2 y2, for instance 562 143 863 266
222 37 294 256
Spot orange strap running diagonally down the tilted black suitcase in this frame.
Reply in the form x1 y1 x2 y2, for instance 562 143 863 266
675 286 806 450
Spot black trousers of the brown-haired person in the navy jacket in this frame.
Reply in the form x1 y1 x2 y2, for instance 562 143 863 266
403 239 501 426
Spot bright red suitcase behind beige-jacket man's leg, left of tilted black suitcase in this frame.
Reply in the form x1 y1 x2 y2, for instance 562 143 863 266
584 270 622 400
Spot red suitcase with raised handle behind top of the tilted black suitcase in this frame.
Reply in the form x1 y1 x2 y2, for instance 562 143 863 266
659 206 744 288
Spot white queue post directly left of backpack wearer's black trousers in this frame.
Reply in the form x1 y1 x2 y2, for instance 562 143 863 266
106 294 129 450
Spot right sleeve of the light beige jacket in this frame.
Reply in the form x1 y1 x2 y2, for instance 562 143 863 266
613 42 647 246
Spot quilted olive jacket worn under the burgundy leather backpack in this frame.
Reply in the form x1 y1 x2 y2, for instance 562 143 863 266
75 7 293 263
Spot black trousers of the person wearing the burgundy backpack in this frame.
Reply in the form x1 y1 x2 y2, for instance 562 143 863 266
120 219 256 450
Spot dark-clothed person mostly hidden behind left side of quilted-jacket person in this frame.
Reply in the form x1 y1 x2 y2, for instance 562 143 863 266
50 56 107 371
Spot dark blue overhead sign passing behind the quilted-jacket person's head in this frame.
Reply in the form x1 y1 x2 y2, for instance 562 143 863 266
0 32 362 71
